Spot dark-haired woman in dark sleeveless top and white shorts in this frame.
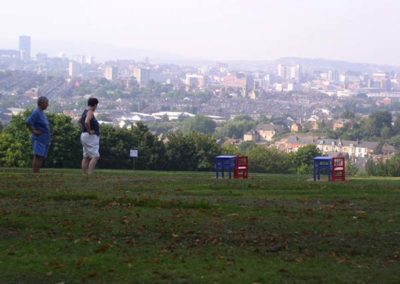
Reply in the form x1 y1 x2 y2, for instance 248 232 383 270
79 98 100 176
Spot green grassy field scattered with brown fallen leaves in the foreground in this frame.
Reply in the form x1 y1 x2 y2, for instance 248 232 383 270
0 169 400 283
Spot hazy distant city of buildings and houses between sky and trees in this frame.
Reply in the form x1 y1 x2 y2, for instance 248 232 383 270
0 35 400 165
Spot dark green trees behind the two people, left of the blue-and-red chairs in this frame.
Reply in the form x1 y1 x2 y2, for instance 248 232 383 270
0 111 221 171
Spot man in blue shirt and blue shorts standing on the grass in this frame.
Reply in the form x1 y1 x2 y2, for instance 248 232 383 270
26 97 50 173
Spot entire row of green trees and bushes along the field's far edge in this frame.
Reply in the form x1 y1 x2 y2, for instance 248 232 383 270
0 110 400 176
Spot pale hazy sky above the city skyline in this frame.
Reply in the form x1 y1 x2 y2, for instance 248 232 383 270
0 0 400 65
